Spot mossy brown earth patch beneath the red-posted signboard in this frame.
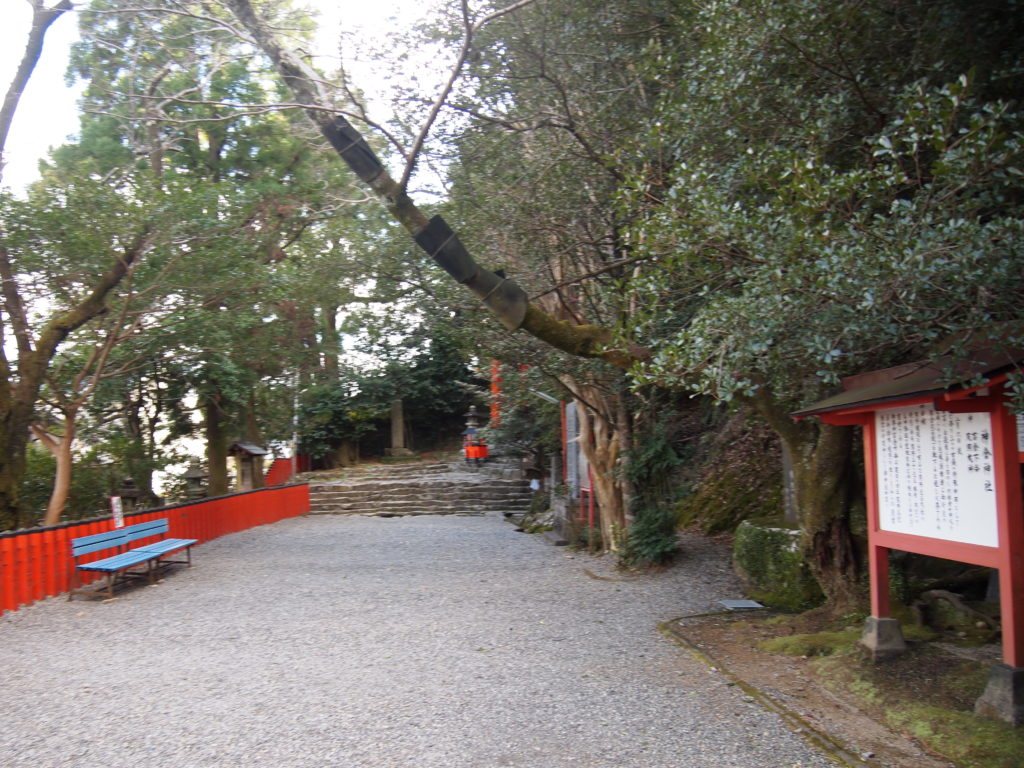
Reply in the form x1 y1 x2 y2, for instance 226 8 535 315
680 611 1024 768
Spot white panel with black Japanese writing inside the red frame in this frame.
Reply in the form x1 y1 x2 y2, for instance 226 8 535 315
874 406 999 547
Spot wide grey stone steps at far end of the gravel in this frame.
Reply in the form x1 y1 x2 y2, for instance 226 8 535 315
309 460 532 517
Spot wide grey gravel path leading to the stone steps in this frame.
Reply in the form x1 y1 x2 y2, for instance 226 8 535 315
0 515 833 768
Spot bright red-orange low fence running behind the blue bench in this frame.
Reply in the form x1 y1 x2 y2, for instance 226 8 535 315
0 485 309 612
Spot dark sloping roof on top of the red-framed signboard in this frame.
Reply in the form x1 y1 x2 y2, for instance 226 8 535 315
791 349 1024 419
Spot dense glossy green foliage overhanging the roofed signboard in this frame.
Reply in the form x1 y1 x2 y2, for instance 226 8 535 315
629 0 1024 404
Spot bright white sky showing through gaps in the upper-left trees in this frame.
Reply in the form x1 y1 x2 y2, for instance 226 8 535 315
0 0 437 189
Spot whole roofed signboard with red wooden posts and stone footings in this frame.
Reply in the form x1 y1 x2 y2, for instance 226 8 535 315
794 358 1024 725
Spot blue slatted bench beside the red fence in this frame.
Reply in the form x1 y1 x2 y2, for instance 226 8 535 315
68 519 199 600
